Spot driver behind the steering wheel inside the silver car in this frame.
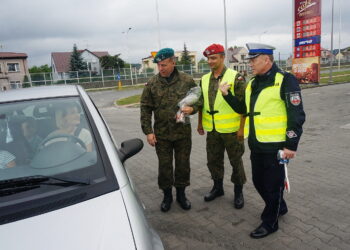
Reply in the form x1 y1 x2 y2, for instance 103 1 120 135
47 103 93 152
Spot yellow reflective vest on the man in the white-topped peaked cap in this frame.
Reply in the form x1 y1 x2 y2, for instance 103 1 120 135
244 73 287 142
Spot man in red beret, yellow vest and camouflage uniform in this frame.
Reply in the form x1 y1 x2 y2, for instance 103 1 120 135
197 44 246 209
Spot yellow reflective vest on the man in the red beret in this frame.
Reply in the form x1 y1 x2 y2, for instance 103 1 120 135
202 69 241 133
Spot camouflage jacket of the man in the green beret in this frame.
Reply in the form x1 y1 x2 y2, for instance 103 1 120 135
141 68 198 140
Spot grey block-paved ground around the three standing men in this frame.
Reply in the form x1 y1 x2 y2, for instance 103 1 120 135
96 84 350 250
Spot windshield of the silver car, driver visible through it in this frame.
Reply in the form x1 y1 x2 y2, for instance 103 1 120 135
0 97 105 185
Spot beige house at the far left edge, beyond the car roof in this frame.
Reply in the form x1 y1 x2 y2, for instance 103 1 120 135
0 52 29 91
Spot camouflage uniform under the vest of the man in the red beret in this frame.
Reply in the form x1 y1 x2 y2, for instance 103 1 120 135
202 67 246 185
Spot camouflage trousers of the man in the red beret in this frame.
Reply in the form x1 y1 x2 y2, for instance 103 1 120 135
207 130 247 185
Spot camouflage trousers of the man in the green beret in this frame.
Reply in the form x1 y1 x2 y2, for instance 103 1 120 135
156 137 192 189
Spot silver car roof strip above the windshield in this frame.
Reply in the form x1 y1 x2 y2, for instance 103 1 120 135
0 85 79 103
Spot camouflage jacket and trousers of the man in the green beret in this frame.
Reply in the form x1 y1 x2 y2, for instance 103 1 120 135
141 68 198 190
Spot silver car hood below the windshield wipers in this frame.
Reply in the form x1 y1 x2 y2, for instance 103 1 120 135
0 191 135 250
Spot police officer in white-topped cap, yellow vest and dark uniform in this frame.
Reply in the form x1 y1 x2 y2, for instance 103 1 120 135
220 43 305 238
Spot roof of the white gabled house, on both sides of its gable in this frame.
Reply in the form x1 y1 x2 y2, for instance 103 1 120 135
51 49 109 73
